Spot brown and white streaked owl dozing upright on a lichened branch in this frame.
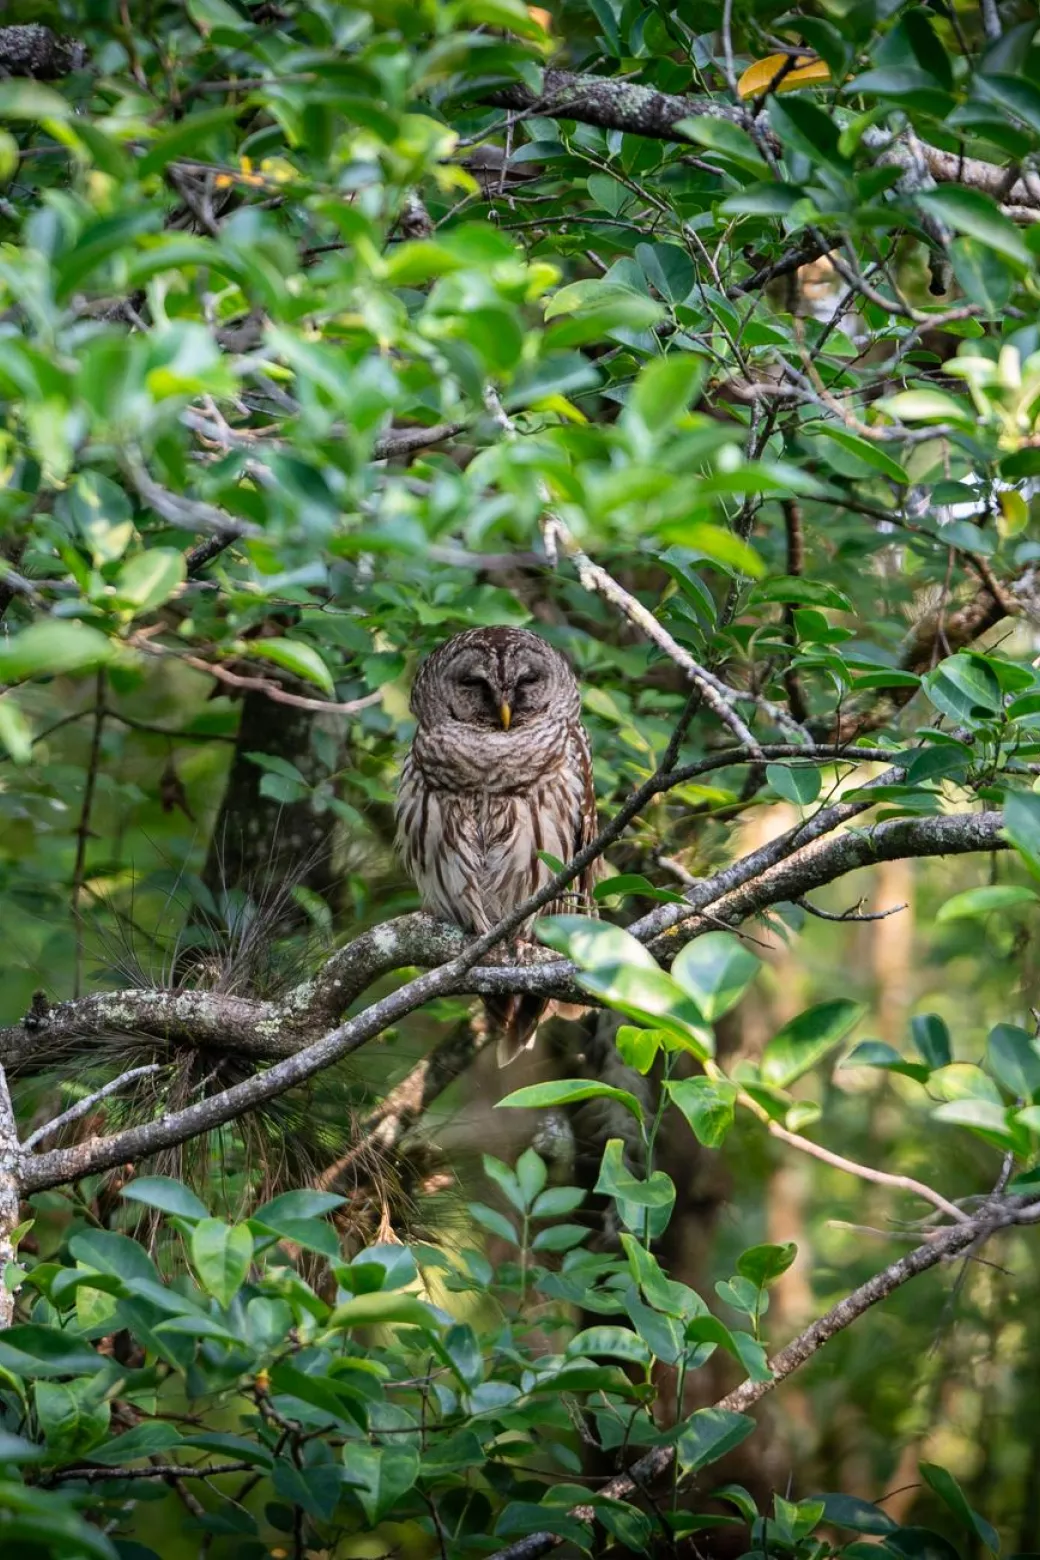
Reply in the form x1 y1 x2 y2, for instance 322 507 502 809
398 627 596 1062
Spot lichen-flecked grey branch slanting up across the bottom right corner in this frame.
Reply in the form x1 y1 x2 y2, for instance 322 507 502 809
488 1197 1040 1560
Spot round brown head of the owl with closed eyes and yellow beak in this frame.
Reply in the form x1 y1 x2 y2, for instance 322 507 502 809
412 629 580 732
